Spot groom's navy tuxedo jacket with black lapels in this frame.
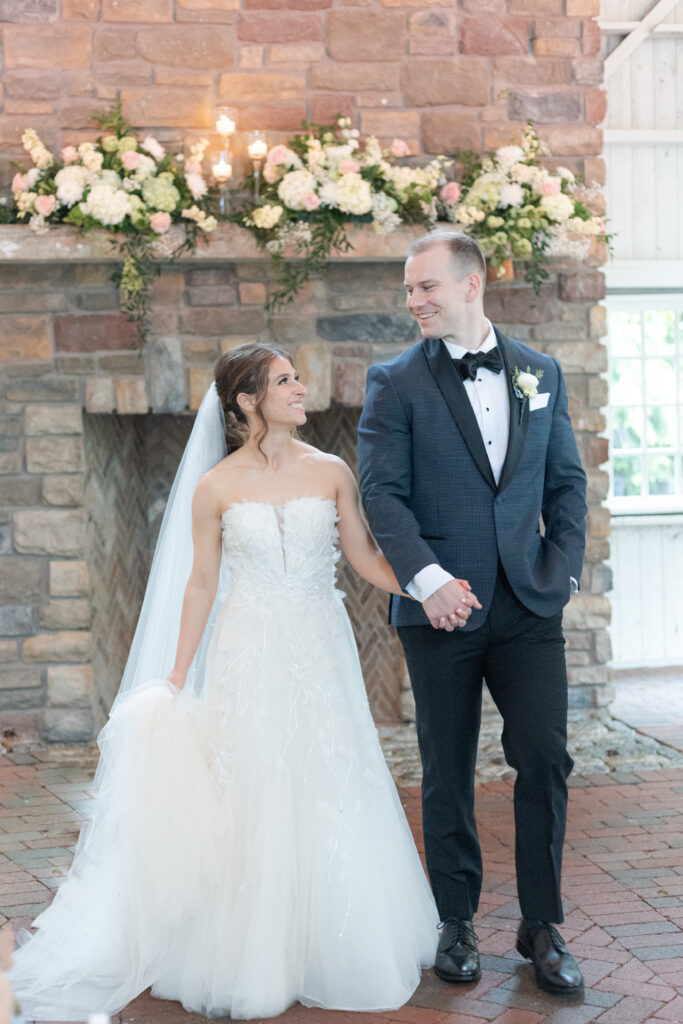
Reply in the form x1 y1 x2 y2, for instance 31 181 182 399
358 330 587 630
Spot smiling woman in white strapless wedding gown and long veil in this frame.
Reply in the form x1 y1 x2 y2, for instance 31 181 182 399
11 344 479 1021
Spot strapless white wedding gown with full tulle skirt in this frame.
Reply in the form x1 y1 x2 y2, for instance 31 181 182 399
10 498 437 1021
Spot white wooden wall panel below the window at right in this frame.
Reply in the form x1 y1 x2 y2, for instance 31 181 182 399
610 515 683 669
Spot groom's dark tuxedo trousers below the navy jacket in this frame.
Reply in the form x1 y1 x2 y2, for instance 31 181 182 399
398 567 573 924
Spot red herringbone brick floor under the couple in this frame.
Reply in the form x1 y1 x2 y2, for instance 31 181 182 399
0 748 683 1024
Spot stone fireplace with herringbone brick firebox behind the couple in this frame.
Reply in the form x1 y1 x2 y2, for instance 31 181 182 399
0 225 610 740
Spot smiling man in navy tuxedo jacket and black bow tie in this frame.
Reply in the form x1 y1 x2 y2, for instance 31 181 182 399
358 231 587 993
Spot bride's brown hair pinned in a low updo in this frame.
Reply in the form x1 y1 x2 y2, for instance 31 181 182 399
214 342 292 454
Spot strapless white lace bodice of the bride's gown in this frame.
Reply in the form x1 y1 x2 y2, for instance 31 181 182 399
222 498 339 596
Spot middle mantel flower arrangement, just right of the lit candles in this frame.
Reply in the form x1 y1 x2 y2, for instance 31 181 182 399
231 117 451 310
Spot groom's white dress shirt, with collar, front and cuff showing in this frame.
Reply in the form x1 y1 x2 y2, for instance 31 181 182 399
405 319 510 601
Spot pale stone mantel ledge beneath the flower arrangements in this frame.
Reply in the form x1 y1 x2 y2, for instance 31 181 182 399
0 223 438 265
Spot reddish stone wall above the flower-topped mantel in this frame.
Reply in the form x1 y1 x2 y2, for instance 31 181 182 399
0 0 604 180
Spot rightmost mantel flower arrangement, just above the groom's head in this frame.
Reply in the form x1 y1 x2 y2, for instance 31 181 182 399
441 122 611 295
